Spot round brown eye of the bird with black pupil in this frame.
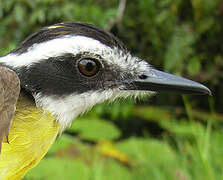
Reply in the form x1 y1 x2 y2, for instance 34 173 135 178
78 58 100 77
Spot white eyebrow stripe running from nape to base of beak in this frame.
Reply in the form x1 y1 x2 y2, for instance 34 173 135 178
0 35 149 72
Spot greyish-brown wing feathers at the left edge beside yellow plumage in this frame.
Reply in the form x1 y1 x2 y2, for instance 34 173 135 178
0 66 20 151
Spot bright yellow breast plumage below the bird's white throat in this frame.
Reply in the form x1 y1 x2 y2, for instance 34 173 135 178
0 93 59 180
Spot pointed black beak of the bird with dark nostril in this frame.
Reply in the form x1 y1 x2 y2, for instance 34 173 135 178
123 69 211 95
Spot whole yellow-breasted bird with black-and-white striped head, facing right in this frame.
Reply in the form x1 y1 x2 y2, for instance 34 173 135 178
0 22 211 180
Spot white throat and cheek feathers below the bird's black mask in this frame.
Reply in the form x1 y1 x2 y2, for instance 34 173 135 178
34 89 152 131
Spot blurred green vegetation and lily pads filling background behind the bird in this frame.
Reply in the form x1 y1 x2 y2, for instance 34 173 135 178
0 0 223 180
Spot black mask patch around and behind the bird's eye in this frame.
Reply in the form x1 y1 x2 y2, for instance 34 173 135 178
15 53 110 95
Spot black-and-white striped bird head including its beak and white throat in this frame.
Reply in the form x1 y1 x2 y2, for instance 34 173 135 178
0 23 210 128
